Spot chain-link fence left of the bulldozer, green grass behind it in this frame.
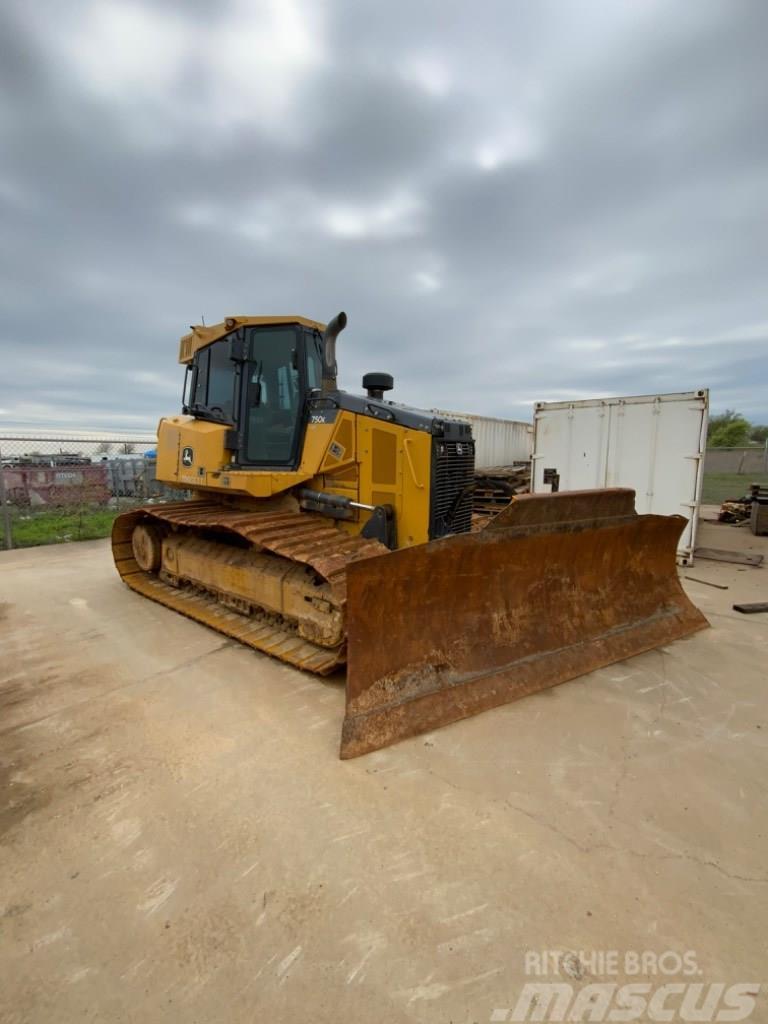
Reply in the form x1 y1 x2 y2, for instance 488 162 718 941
0 432 179 549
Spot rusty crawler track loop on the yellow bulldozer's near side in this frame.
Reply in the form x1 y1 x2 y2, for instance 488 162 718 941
112 502 387 675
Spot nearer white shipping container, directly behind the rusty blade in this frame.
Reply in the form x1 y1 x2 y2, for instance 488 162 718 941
531 388 709 565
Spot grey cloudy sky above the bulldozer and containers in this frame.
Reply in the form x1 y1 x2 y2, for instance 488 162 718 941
0 0 768 429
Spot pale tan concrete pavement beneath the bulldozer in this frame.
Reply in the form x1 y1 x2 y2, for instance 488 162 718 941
0 524 768 1024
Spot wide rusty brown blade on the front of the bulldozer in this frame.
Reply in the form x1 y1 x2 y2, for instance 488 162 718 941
341 489 709 758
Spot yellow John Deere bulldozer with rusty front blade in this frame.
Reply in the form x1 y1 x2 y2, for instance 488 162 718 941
112 312 708 758
